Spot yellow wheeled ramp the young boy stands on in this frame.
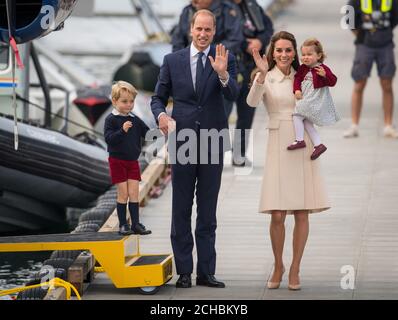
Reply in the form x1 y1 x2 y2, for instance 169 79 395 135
0 232 173 294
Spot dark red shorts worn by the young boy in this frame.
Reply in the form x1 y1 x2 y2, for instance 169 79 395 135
108 157 141 184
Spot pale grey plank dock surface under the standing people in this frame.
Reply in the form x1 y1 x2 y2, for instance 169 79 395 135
83 0 398 300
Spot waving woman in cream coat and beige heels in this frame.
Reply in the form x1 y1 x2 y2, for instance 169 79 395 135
247 31 330 290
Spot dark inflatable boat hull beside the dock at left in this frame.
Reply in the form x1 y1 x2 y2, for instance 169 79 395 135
0 116 111 232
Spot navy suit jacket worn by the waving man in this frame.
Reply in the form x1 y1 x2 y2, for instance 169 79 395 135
151 46 239 132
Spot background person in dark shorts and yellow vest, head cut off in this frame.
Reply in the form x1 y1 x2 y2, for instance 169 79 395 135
343 0 398 138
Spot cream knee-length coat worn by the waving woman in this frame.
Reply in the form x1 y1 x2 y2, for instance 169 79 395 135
247 67 330 213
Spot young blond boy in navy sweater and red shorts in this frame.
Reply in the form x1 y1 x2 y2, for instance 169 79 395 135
104 81 152 235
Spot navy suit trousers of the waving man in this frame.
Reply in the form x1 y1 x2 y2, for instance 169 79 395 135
171 153 223 275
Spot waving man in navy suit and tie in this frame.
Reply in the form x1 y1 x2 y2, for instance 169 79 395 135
151 10 239 288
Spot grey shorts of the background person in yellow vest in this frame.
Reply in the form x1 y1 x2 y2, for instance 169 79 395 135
351 44 396 81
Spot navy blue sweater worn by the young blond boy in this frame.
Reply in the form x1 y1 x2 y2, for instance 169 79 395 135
104 113 149 160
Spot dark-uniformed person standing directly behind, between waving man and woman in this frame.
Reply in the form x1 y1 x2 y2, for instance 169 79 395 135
232 0 274 167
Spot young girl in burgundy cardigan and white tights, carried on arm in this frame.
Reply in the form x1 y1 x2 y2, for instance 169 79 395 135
287 38 340 160
